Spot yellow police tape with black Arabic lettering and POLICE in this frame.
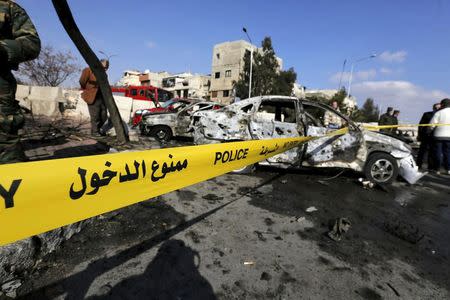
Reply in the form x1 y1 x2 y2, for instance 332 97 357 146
0 136 316 245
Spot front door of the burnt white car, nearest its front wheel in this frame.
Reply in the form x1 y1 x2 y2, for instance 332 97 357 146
301 101 364 170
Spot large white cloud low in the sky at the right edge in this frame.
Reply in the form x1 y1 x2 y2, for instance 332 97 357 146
352 81 449 123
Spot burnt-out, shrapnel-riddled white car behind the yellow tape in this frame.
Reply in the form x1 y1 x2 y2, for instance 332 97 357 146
193 96 424 184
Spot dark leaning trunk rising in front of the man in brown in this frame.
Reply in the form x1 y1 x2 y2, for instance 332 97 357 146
52 0 128 144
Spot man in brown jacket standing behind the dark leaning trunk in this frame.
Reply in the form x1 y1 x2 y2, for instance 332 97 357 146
80 59 109 137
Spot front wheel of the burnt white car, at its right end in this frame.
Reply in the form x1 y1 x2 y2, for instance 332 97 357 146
364 153 398 184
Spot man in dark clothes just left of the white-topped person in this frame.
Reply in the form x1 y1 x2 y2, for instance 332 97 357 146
417 103 441 170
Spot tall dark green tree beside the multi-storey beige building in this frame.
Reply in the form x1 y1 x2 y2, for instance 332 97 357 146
234 37 297 99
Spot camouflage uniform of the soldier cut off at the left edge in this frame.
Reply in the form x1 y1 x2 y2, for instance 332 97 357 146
0 0 41 164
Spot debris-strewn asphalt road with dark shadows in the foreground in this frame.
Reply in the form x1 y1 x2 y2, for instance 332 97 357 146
18 165 450 299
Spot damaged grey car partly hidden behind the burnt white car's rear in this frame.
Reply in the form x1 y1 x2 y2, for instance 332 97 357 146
139 100 223 142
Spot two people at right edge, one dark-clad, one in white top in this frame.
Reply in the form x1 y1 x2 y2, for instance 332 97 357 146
417 98 450 175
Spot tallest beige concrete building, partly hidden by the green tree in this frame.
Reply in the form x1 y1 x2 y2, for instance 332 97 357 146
210 40 283 104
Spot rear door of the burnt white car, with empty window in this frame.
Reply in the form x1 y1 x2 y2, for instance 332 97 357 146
249 98 303 165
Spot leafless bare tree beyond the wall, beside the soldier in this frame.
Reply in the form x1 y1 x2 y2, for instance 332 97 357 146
19 45 81 86
